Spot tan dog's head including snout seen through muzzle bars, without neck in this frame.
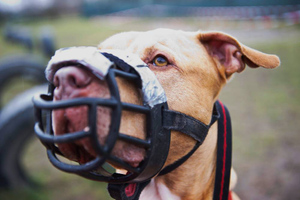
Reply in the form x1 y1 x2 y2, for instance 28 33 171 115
34 29 279 183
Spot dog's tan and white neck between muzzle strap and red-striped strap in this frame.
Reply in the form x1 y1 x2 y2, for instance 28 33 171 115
140 123 217 200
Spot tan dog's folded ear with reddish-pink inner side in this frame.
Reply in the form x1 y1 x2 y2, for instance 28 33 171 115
198 32 280 78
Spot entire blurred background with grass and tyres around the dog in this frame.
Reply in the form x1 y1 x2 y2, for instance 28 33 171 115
0 0 300 200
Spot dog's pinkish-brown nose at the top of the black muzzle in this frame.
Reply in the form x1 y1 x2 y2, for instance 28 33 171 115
53 66 92 100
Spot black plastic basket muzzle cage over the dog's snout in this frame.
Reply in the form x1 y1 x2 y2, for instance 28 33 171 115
33 49 170 183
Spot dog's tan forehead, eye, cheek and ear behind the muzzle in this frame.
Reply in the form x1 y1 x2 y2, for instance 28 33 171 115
99 29 280 121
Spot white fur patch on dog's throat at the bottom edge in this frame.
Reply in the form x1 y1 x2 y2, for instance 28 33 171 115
140 179 180 200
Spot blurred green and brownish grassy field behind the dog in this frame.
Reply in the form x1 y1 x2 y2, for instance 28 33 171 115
0 17 300 200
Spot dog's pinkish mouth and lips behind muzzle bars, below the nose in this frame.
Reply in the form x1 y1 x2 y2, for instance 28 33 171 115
53 106 145 168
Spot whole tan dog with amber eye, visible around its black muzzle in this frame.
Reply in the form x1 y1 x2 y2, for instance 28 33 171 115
54 29 280 200
